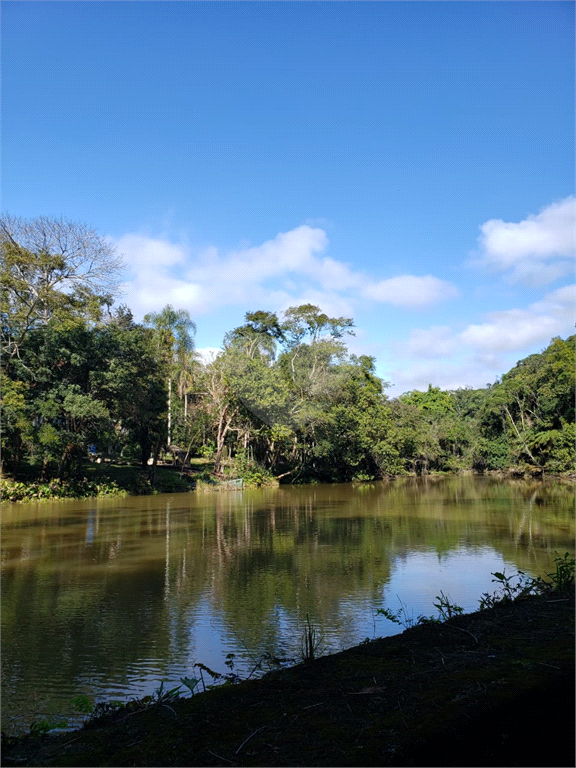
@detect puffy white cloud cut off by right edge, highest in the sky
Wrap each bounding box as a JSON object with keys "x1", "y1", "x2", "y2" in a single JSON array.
[{"x1": 478, "y1": 196, "x2": 576, "y2": 285}]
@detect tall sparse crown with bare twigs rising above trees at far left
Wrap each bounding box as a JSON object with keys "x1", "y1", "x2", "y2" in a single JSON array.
[{"x1": 0, "y1": 215, "x2": 123, "y2": 365}]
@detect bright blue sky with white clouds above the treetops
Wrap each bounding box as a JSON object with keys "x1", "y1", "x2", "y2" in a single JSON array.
[{"x1": 1, "y1": 0, "x2": 575, "y2": 396}]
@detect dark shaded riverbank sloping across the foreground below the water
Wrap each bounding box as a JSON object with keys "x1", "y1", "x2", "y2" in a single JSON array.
[{"x1": 2, "y1": 586, "x2": 574, "y2": 767}]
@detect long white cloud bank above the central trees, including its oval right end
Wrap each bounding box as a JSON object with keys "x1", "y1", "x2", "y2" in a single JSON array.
[{"x1": 116, "y1": 225, "x2": 458, "y2": 316}]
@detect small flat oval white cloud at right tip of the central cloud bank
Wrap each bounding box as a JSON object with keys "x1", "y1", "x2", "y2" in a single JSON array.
[{"x1": 362, "y1": 275, "x2": 460, "y2": 309}]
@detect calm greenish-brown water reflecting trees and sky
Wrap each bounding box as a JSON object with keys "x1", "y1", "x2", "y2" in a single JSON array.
[{"x1": 2, "y1": 477, "x2": 574, "y2": 732}]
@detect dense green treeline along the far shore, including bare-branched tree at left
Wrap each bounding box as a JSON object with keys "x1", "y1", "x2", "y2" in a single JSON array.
[{"x1": 0, "y1": 217, "x2": 575, "y2": 482}]
